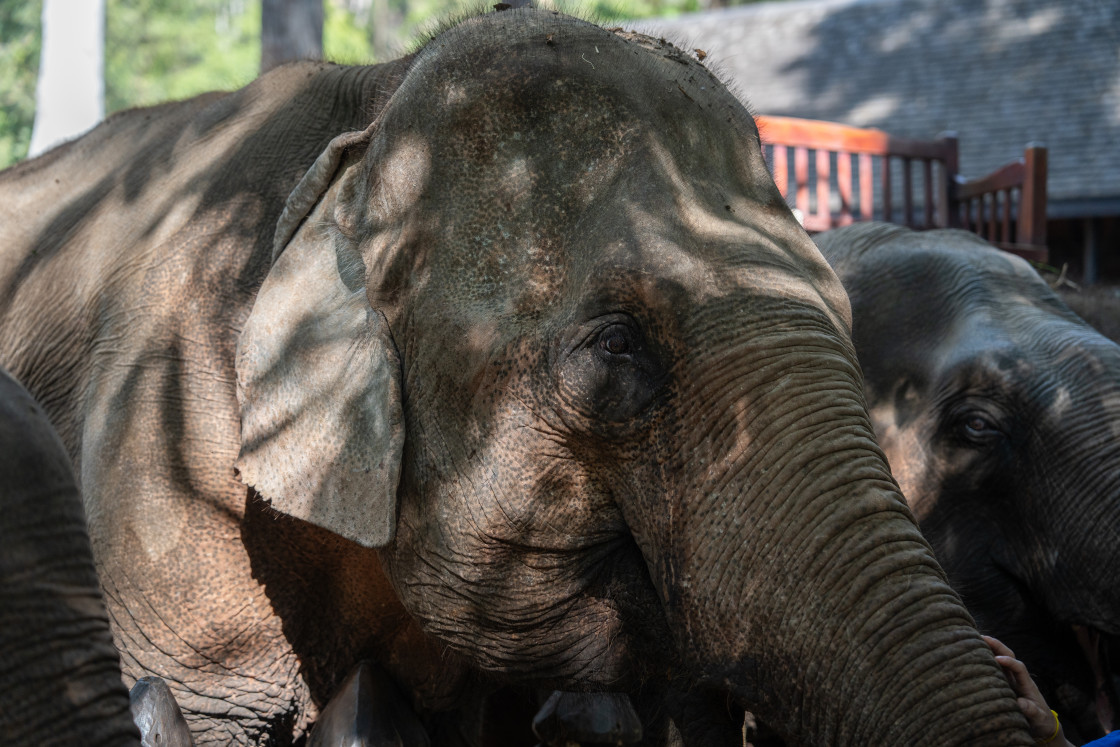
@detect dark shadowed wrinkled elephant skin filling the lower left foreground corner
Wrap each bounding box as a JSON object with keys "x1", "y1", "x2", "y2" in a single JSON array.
[{"x1": 0, "y1": 371, "x2": 140, "y2": 747}]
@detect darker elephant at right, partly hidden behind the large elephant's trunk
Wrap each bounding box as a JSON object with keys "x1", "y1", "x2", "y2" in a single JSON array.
[{"x1": 816, "y1": 224, "x2": 1120, "y2": 740}]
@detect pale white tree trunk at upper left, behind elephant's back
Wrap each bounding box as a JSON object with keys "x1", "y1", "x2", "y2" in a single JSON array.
[{"x1": 28, "y1": 0, "x2": 105, "y2": 156}]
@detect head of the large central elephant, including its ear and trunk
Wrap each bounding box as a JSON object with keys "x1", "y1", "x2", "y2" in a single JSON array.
[{"x1": 237, "y1": 10, "x2": 1029, "y2": 745}]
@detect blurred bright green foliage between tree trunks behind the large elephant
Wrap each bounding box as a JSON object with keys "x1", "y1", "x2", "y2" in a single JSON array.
[{"x1": 0, "y1": 0, "x2": 770, "y2": 168}]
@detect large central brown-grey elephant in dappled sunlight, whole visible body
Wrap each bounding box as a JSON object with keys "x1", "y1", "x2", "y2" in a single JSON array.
[{"x1": 0, "y1": 9, "x2": 1030, "y2": 745}]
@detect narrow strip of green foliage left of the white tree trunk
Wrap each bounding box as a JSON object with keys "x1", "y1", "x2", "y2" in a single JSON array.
[{"x1": 0, "y1": 0, "x2": 43, "y2": 168}]
